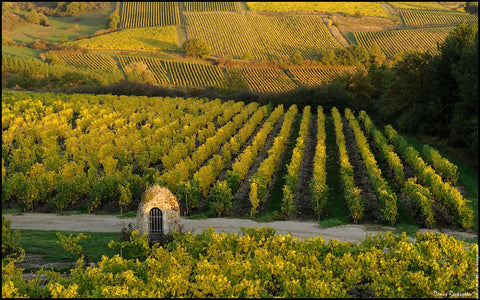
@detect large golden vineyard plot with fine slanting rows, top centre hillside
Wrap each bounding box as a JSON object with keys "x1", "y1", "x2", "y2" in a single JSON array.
[{"x1": 185, "y1": 12, "x2": 340, "y2": 59}]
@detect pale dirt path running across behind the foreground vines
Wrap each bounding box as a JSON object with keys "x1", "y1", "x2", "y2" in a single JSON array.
[{"x1": 2, "y1": 213, "x2": 477, "y2": 242}]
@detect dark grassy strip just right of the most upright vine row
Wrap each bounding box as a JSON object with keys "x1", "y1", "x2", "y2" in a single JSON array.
[{"x1": 320, "y1": 116, "x2": 348, "y2": 227}]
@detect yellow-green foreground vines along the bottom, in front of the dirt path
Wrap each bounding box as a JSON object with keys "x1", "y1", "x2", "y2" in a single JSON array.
[{"x1": 2, "y1": 227, "x2": 478, "y2": 298}]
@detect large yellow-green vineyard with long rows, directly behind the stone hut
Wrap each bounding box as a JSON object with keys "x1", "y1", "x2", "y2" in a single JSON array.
[{"x1": 2, "y1": 92, "x2": 474, "y2": 229}]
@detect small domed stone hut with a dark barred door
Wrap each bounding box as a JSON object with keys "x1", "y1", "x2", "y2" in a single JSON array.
[{"x1": 137, "y1": 185, "x2": 180, "y2": 241}]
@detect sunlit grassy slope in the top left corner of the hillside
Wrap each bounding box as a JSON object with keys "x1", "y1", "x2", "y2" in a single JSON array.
[{"x1": 2, "y1": 2, "x2": 115, "y2": 43}]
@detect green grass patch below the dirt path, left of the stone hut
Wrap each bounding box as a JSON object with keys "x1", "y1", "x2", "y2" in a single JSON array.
[{"x1": 19, "y1": 230, "x2": 120, "y2": 262}]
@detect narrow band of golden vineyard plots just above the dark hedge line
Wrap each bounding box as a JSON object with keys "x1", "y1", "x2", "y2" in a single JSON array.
[{"x1": 54, "y1": 54, "x2": 356, "y2": 93}]
